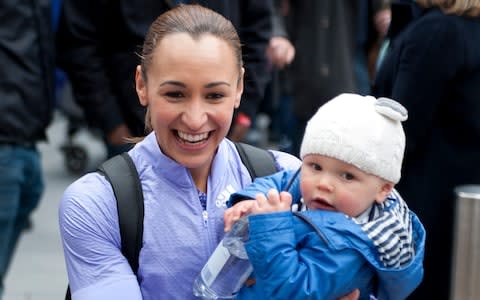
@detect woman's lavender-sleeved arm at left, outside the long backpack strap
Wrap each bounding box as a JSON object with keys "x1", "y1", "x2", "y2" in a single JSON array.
[{"x1": 59, "y1": 174, "x2": 142, "y2": 300}]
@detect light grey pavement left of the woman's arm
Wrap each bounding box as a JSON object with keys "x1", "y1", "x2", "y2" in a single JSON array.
[{"x1": 3, "y1": 115, "x2": 104, "y2": 300}]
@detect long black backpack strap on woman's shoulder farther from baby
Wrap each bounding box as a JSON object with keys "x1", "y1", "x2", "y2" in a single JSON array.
[{"x1": 98, "y1": 153, "x2": 144, "y2": 274}]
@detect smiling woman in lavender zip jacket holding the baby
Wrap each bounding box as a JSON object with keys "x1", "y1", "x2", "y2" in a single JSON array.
[{"x1": 59, "y1": 5, "x2": 300, "y2": 300}]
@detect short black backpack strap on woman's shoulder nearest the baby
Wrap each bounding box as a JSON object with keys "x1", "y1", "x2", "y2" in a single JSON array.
[{"x1": 234, "y1": 142, "x2": 277, "y2": 180}]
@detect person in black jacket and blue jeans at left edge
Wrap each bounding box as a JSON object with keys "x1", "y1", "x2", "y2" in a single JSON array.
[{"x1": 0, "y1": 0, "x2": 54, "y2": 299}]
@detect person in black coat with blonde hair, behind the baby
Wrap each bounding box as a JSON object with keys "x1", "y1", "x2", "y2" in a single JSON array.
[{"x1": 373, "y1": 0, "x2": 480, "y2": 300}]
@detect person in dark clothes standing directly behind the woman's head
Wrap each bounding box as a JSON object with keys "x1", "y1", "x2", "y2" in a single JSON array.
[{"x1": 57, "y1": 0, "x2": 273, "y2": 156}]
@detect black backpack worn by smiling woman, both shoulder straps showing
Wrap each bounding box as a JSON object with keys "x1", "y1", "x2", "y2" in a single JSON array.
[{"x1": 65, "y1": 142, "x2": 277, "y2": 300}]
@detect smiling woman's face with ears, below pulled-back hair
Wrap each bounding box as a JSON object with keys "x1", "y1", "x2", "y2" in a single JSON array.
[{"x1": 136, "y1": 33, "x2": 243, "y2": 173}]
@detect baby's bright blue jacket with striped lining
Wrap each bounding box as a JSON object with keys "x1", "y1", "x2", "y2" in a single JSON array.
[{"x1": 229, "y1": 171, "x2": 425, "y2": 300}]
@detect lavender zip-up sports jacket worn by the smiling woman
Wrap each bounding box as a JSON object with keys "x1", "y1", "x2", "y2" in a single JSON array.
[{"x1": 59, "y1": 133, "x2": 301, "y2": 300}]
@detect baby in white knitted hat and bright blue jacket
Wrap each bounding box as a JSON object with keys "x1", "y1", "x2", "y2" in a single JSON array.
[{"x1": 225, "y1": 94, "x2": 425, "y2": 299}]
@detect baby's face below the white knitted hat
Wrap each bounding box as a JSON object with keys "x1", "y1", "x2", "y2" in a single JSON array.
[{"x1": 300, "y1": 154, "x2": 393, "y2": 217}]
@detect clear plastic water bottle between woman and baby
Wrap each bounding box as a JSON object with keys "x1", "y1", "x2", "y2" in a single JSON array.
[{"x1": 193, "y1": 217, "x2": 253, "y2": 300}]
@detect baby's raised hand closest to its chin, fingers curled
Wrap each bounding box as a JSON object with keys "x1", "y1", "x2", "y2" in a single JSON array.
[{"x1": 251, "y1": 189, "x2": 292, "y2": 214}]
